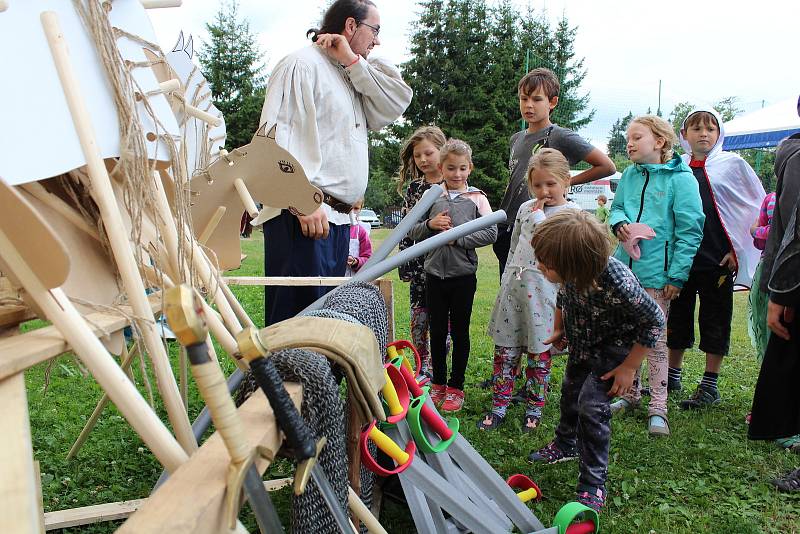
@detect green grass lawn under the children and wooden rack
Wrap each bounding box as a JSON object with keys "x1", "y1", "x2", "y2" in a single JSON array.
[{"x1": 26, "y1": 230, "x2": 800, "y2": 534}]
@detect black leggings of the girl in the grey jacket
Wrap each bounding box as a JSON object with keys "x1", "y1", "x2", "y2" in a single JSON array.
[{"x1": 425, "y1": 273, "x2": 478, "y2": 389}]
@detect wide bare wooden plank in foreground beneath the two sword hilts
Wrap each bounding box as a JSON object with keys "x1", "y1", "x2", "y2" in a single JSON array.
[{"x1": 117, "y1": 382, "x2": 302, "y2": 534}]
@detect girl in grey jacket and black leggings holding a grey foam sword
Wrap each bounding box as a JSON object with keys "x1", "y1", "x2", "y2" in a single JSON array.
[{"x1": 410, "y1": 139, "x2": 497, "y2": 412}]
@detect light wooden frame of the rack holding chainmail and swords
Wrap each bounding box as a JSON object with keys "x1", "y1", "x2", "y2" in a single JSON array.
[{"x1": 0, "y1": 277, "x2": 394, "y2": 533}]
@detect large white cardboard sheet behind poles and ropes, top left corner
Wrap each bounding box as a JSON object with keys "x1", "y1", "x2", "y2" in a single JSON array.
[{"x1": 0, "y1": 0, "x2": 178, "y2": 184}]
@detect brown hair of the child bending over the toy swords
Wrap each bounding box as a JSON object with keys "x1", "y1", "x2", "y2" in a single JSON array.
[{"x1": 531, "y1": 209, "x2": 611, "y2": 291}]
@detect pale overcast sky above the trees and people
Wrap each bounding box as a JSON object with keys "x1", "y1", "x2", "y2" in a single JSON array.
[{"x1": 150, "y1": 0, "x2": 800, "y2": 150}]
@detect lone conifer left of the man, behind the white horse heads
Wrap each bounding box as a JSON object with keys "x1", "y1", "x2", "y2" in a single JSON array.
[{"x1": 199, "y1": 0, "x2": 265, "y2": 149}]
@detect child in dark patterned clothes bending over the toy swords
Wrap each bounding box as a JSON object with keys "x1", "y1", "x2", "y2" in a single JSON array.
[{"x1": 528, "y1": 210, "x2": 665, "y2": 510}]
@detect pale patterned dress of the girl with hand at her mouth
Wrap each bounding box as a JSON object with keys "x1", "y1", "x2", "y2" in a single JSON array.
[{"x1": 489, "y1": 199, "x2": 580, "y2": 354}]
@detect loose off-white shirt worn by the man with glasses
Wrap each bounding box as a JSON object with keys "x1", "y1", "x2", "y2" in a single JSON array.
[{"x1": 257, "y1": 45, "x2": 412, "y2": 224}]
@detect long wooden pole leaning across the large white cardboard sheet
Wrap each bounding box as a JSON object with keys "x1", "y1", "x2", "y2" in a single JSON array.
[{"x1": 41, "y1": 11, "x2": 197, "y2": 453}]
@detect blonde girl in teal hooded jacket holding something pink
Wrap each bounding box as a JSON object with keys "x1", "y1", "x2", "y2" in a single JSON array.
[{"x1": 609, "y1": 115, "x2": 705, "y2": 436}]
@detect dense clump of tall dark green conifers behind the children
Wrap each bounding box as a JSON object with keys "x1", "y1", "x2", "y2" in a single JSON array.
[{"x1": 393, "y1": 0, "x2": 593, "y2": 205}]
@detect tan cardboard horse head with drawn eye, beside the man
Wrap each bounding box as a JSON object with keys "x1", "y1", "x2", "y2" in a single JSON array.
[{"x1": 191, "y1": 124, "x2": 322, "y2": 270}]
